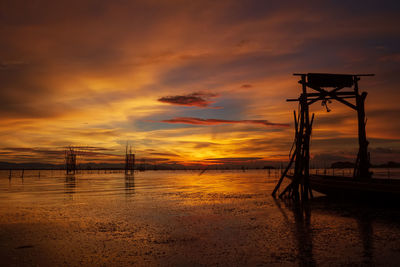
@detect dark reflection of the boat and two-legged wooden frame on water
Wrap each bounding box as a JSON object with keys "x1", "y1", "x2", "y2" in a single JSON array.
[{"x1": 274, "y1": 197, "x2": 386, "y2": 266}]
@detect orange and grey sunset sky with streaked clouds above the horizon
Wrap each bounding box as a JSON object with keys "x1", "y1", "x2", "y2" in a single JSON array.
[{"x1": 0, "y1": 0, "x2": 400, "y2": 168}]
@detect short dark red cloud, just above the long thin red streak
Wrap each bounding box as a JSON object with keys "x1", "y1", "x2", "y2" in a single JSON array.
[{"x1": 158, "y1": 92, "x2": 218, "y2": 107}]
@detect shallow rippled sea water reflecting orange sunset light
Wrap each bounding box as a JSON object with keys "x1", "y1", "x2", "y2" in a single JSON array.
[{"x1": 0, "y1": 170, "x2": 400, "y2": 266}]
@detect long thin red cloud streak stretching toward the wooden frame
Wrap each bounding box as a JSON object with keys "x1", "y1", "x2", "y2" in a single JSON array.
[{"x1": 162, "y1": 117, "x2": 289, "y2": 127}]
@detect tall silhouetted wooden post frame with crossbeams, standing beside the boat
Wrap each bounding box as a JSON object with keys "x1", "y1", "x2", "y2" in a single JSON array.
[{"x1": 272, "y1": 73, "x2": 373, "y2": 199}]
